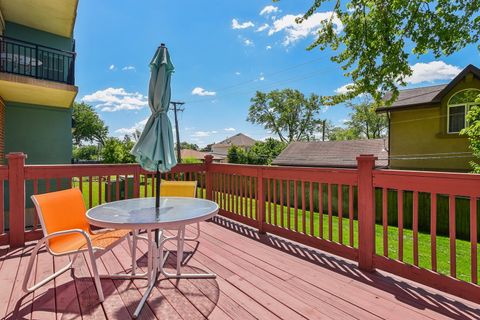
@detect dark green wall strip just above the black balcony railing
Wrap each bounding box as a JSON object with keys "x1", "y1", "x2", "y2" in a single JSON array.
[{"x1": 5, "y1": 21, "x2": 73, "y2": 51}]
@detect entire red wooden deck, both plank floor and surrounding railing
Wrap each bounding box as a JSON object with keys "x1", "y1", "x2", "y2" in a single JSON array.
[{"x1": 0, "y1": 154, "x2": 480, "y2": 319}]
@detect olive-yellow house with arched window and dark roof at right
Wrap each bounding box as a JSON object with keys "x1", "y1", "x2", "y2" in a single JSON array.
[{"x1": 377, "y1": 65, "x2": 480, "y2": 171}]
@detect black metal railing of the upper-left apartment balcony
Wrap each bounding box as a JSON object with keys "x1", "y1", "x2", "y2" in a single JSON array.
[{"x1": 0, "y1": 36, "x2": 75, "y2": 85}]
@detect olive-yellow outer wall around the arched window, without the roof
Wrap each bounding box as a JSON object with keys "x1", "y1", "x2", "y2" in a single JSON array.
[{"x1": 390, "y1": 75, "x2": 480, "y2": 171}]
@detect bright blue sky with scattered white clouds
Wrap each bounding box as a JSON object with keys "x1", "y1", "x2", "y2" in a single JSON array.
[{"x1": 75, "y1": 0, "x2": 480, "y2": 146}]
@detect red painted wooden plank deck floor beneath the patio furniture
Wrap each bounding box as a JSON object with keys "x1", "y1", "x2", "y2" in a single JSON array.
[{"x1": 0, "y1": 218, "x2": 480, "y2": 320}]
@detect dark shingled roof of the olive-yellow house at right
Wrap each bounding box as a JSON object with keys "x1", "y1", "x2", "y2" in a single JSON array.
[{"x1": 377, "y1": 64, "x2": 480, "y2": 112}]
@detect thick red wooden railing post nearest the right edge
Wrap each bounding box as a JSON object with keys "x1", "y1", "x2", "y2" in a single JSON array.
[{"x1": 357, "y1": 154, "x2": 377, "y2": 271}]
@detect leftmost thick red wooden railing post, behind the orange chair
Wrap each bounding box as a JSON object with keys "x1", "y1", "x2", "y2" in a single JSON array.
[{"x1": 7, "y1": 152, "x2": 27, "y2": 248}]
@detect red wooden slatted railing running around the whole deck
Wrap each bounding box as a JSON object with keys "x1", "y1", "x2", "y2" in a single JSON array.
[{"x1": 0, "y1": 154, "x2": 480, "y2": 303}]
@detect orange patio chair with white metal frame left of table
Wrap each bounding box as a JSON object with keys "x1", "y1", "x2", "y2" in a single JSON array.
[{"x1": 22, "y1": 189, "x2": 134, "y2": 302}]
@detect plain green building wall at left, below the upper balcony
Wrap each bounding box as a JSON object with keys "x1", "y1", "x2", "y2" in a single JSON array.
[{"x1": 5, "y1": 101, "x2": 72, "y2": 164}]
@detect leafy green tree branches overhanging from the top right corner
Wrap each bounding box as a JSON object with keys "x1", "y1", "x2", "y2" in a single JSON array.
[{"x1": 297, "y1": 0, "x2": 480, "y2": 104}]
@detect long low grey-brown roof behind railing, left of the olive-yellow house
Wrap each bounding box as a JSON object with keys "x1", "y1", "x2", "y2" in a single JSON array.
[{"x1": 272, "y1": 139, "x2": 388, "y2": 168}]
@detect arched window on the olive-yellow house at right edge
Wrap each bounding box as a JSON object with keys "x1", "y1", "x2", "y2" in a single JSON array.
[{"x1": 447, "y1": 89, "x2": 480, "y2": 133}]
